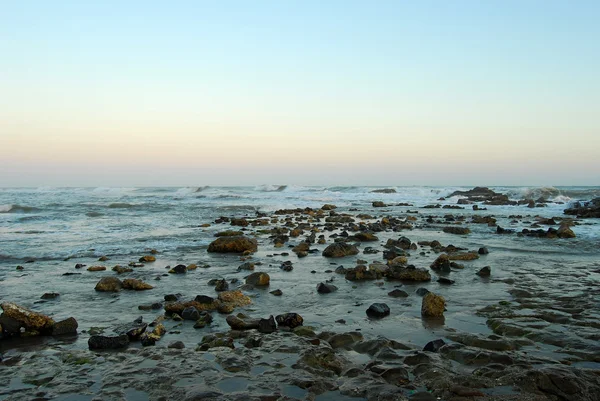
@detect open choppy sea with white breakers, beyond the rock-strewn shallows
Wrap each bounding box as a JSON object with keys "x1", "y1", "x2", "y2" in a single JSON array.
[{"x1": 0, "y1": 185, "x2": 600, "y2": 265}]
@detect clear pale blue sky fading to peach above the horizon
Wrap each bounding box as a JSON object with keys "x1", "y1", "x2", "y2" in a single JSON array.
[{"x1": 0, "y1": 0, "x2": 600, "y2": 187}]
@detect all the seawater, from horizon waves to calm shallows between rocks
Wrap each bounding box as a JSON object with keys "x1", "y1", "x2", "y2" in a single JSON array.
[{"x1": 0, "y1": 185, "x2": 600, "y2": 363}]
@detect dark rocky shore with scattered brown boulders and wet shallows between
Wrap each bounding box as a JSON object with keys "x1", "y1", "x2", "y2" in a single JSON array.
[{"x1": 0, "y1": 187, "x2": 600, "y2": 401}]
